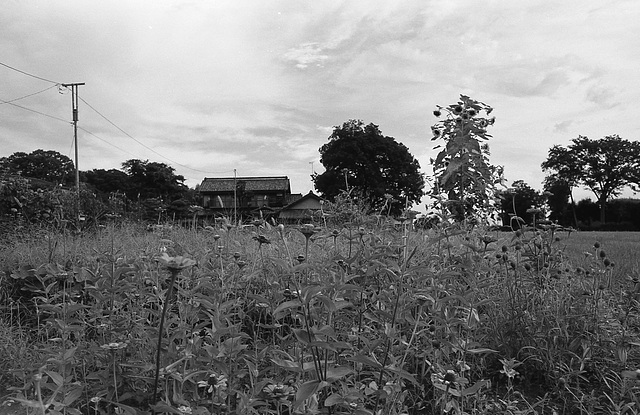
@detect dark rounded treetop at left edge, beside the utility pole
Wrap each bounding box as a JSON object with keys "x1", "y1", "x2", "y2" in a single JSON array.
[{"x1": 0, "y1": 149, "x2": 75, "y2": 184}]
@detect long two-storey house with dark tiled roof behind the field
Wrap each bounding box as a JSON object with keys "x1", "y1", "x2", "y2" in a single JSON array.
[{"x1": 198, "y1": 176, "x2": 291, "y2": 217}]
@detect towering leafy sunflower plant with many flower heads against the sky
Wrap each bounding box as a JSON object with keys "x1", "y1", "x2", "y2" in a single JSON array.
[{"x1": 431, "y1": 95, "x2": 502, "y2": 220}]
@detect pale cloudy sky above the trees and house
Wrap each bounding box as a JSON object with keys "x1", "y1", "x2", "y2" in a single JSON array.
[{"x1": 0, "y1": 0, "x2": 640, "y2": 213}]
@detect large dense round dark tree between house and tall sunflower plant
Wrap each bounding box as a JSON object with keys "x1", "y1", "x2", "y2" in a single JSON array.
[{"x1": 313, "y1": 120, "x2": 424, "y2": 214}]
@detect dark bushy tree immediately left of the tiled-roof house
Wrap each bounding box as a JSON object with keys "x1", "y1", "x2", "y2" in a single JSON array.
[{"x1": 122, "y1": 159, "x2": 188, "y2": 200}]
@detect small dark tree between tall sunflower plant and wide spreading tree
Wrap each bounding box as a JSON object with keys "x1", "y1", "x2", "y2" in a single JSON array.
[{"x1": 498, "y1": 180, "x2": 544, "y2": 229}]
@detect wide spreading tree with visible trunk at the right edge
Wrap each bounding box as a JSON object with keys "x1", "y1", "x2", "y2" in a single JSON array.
[{"x1": 542, "y1": 135, "x2": 640, "y2": 223}]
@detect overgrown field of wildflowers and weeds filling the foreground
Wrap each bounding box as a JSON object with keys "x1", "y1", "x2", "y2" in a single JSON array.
[{"x1": 0, "y1": 218, "x2": 640, "y2": 415}]
